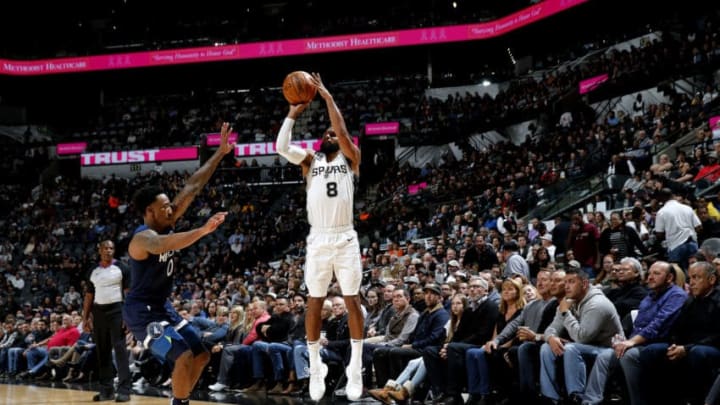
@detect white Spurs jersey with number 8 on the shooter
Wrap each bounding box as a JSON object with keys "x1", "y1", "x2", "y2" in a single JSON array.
[{"x1": 307, "y1": 152, "x2": 355, "y2": 229}]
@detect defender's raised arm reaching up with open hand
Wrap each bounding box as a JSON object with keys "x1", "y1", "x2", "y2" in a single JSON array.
[{"x1": 173, "y1": 122, "x2": 235, "y2": 221}]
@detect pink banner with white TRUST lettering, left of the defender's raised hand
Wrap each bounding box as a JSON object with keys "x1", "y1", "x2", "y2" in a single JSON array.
[{"x1": 80, "y1": 146, "x2": 198, "y2": 166}]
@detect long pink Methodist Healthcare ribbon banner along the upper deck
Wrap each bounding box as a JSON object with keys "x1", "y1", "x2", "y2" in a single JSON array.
[{"x1": 0, "y1": 0, "x2": 588, "y2": 76}]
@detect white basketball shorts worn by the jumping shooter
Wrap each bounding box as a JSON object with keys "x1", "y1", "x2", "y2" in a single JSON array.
[{"x1": 305, "y1": 227, "x2": 362, "y2": 298}]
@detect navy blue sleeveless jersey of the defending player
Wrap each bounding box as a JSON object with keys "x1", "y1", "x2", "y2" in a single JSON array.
[{"x1": 125, "y1": 225, "x2": 175, "y2": 304}]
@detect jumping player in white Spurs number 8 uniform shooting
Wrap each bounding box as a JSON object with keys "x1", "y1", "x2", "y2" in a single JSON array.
[{"x1": 276, "y1": 73, "x2": 363, "y2": 401}]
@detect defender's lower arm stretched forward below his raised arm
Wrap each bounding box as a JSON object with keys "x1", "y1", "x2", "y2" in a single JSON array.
[{"x1": 128, "y1": 212, "x2": 227, "y2": 260}]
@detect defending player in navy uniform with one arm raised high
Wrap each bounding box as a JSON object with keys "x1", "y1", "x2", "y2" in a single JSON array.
[{"x1": 123, "y1": 123, "x2": 234, "y2": 405}]
